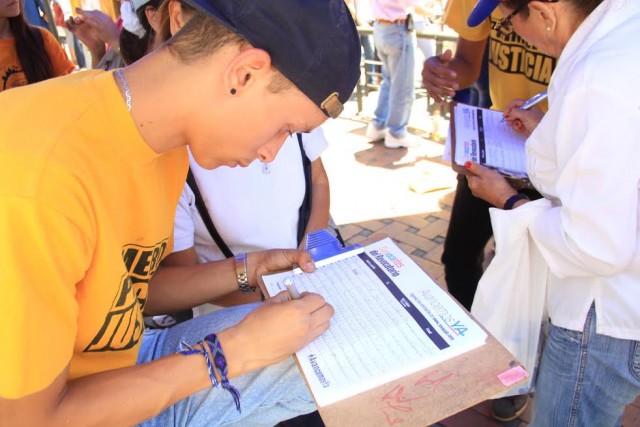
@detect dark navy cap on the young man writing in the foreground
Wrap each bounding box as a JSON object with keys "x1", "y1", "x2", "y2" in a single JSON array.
[{"x1": 183, "y1": 0, "x2": 361, "y2": 118}]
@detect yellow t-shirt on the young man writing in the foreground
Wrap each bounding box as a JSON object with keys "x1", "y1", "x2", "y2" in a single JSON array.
[{"x1": 0, "y1": 71, "x2": 188, "y2": 398}]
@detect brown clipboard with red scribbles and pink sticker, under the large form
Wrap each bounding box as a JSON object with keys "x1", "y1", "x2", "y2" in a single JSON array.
[{"x1": 262, "y1": 230, "x2": 528, "y2": 427}]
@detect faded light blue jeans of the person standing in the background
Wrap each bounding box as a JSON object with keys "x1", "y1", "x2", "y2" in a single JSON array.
[{"x1": 373, "y1": 22, "x2": 416, "y2": 138}]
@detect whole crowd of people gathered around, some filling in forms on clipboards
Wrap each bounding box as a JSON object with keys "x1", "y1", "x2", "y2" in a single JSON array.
[{"x1": 0, "y1": 0, "x2": 640, "y2": 427}]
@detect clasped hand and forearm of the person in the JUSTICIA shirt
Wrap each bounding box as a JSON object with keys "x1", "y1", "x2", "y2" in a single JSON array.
[{"x1": 422, "y1": 38, "x2": 487, "y2": 102}]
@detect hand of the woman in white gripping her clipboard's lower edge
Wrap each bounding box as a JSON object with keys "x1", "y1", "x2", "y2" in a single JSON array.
[{"x1": 464, "y1": 162, "x2": 518, "y2": 209}]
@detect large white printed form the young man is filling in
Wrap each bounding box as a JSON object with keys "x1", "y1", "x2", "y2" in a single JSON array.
[{"x1": 263, "y1": 238, "x2": 487, "y2": 406}]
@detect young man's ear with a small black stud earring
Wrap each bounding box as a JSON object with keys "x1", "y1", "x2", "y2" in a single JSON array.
[{"x1": 225, "y1": 46, "x2": 273, "y2": 92}]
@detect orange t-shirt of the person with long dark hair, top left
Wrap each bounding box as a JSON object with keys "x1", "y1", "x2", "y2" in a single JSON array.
[{"x1": 0, "y1": 27, "x2": 75, "y2": 92}]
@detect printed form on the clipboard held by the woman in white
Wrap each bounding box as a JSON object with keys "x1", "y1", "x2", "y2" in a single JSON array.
[{"x1": 453, "y1": 104, "x2": 527, "y2": 178}]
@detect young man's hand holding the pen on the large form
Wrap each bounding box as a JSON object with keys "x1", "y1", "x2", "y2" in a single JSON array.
[{"x1": 218, "y1": 291, "x2": 334, "y2": 376}]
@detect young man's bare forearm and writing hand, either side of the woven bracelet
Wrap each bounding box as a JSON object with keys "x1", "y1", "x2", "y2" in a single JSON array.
[{"x1": 0, "y1": 292, "x2": 333, "y2": 427}]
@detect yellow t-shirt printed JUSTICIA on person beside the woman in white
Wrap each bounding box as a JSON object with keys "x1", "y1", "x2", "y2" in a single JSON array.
[{"x1": 444, "y1": 0, "x2": 555, "y2": 110}]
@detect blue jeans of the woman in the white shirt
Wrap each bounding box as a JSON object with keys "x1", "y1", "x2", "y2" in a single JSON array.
[{"x1": 530, "y1": 305, "x2": 640, "y2": 427}]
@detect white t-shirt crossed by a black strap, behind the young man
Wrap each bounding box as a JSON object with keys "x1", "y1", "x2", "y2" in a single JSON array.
[{"x1": 173, "y1": 128, "x2": 328, "y2": 263}]
